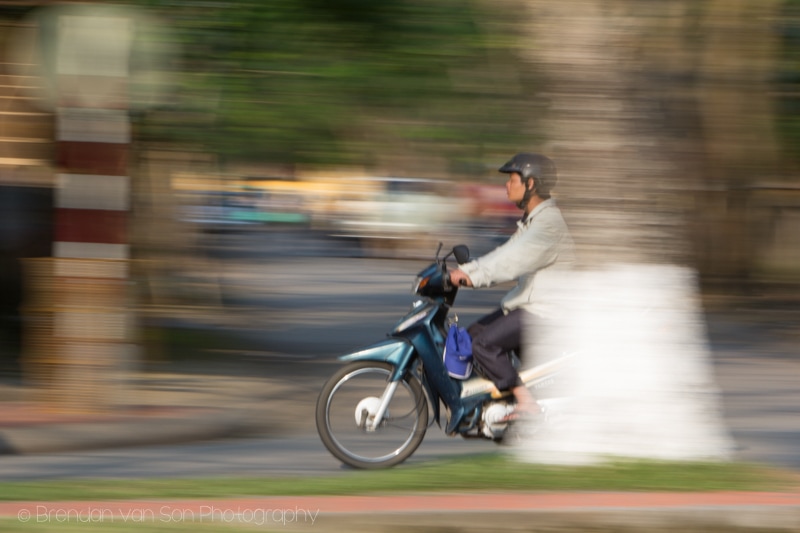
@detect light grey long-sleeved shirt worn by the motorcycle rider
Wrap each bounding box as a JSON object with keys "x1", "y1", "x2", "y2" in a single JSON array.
[{"x1": 460, "y1": 198, "x2": 575, "y2": 317}]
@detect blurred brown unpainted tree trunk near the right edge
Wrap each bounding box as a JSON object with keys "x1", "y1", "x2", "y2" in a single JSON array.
[{"x1": 692, "y1": 0, "x2": 782, "y2": 288}]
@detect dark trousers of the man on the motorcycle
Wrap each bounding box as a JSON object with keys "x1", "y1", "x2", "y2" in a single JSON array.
[{"x1": 467, "y1": 309, "x2": 527, "y2": 390}]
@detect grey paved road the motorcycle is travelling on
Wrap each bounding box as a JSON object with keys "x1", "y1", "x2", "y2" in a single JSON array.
[{"x1": 0, "y1": 231, "x2": 800, "y2": 479}]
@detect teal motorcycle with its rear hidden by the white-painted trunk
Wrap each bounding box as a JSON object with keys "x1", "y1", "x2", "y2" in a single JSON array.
[{"x1": 316, "y1": 245, "x2": 570, "y2": 469}]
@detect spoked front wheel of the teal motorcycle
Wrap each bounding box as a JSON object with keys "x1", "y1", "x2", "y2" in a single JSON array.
[{"x1": 316, "y1": 361, "x2": 428, "y2": 469}]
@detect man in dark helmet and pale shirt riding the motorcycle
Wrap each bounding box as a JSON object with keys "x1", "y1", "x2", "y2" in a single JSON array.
[{"x1": 450, "y1": 153, "x2": 575, "y2": 419}]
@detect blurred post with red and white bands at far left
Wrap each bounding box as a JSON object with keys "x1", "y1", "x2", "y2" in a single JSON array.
[{"x1": 29, "y1": 13, "x2": 134, "y2": 411}]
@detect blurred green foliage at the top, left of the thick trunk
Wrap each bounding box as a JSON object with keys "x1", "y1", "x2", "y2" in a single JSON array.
[{"x1": 125, "y1": 0, "x2": 533, "y2": 170}]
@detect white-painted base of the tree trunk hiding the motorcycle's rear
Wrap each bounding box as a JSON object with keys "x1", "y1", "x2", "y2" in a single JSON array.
[{"x1": 516, "y1": 264, "x2": 732, "y2": 464}]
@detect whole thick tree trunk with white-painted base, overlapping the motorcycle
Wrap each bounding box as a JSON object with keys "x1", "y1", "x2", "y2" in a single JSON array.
[{"x1": 515, "y1": 0, "x2": 732, "y2": 464}]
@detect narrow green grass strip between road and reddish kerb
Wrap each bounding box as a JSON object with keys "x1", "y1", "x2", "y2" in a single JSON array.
[{"x1": 0, "y1": 454, "x2": 797, "y2": 501}]
